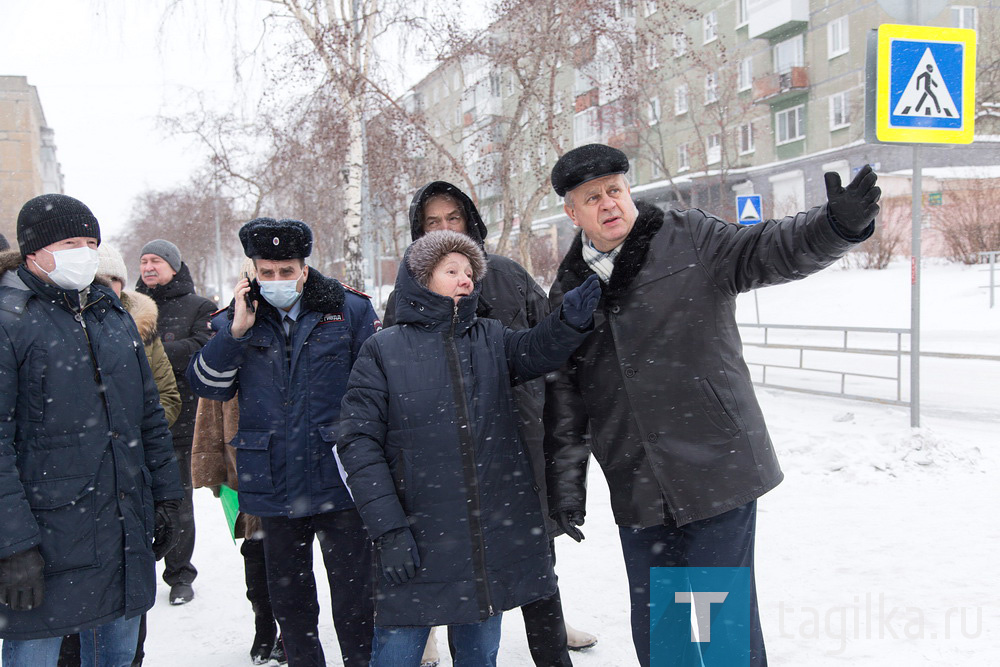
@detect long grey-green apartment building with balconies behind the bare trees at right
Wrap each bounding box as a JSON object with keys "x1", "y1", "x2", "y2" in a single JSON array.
[{"x1": 386, "y1": 0, "x2": 1000, "y2": 264}]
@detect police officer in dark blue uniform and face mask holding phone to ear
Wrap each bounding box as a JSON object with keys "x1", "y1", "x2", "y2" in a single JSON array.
[{"x1": 187, "y1": 218, "x2": 382, "y2": 667}]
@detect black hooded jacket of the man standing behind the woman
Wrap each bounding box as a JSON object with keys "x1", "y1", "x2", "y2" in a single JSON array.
[{"x1": 382, "y1": 181, "x2": 559, "y2": 535}]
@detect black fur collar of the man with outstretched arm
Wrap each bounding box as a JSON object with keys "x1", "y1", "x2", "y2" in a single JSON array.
[{"x1": 556, "y1": 201, "x2": 664, "y2": 298}]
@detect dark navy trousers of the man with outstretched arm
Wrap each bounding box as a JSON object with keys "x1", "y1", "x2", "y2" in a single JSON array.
[{"x1": 618, "y1": 501, "x2": 767, "y2": 667}]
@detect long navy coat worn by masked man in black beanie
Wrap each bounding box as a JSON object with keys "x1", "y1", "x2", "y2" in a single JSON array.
[{"x1": 0, "y1": 253, "x2": 182, "y2": 639}]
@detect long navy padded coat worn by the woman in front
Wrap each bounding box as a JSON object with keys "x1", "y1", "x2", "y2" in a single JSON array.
[{"x1": 337, "y1": 251, "x2": 587, "y2": 626}]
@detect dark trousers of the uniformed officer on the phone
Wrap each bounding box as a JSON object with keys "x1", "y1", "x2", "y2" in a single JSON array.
[{"x1": 261, "y1": 508, "x2": 375, "y2": 667}]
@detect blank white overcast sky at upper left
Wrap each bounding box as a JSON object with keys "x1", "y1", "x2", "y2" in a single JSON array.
[{"x1": 0, "y1": 0, "x2": 470, "y2": 236}]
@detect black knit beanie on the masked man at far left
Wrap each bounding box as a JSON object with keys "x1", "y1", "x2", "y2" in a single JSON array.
[{"x1": 17, "y1": 194, "x2": 101, "y2": 257}]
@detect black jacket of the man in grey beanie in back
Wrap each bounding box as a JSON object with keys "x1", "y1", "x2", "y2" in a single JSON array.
[{"x1": 135, "y1": 262, "x2": 217, "y2": 449}]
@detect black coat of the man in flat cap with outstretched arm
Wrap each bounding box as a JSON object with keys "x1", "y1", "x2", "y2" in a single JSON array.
[{"x1": 545, "y1": 202, "x2": 871, "y2": 528}]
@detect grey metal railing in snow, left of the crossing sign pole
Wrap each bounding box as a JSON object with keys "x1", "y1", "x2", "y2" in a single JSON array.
[{"x1": 739, "y1": 324, "x2": 910, "y2": 406}]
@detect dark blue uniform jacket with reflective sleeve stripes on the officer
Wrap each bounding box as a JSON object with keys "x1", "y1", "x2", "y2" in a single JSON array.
[{"x1": 187, "y1": 267, "x2": 382, "y2": 518}]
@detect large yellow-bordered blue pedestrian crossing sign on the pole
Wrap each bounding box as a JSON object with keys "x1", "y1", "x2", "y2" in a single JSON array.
[{"x1": 875, "y1": 24, "x2": 976, "y2": 144}]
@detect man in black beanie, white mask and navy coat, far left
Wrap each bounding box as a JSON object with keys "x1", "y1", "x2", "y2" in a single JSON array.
[{"x1": 0, "y1": 194, "x2": 182, "y2": 667}]
